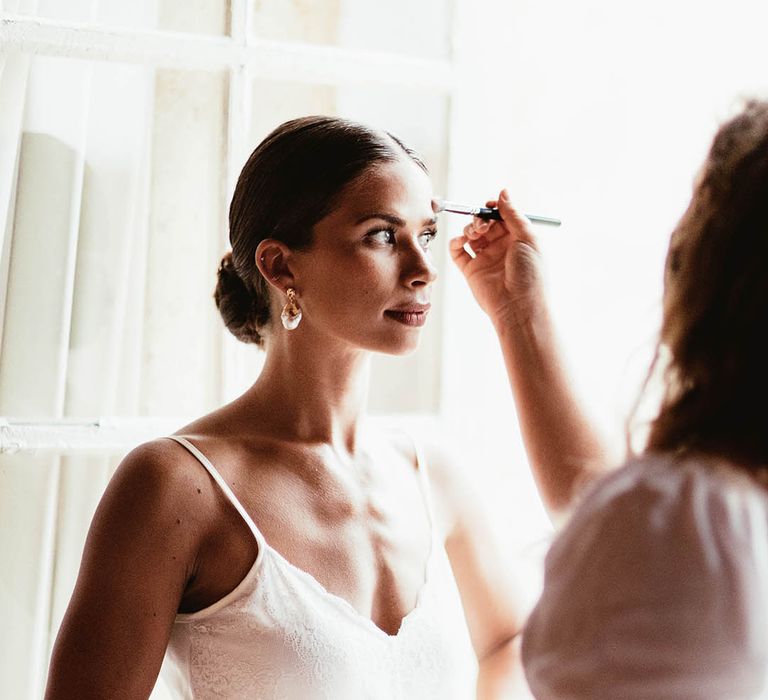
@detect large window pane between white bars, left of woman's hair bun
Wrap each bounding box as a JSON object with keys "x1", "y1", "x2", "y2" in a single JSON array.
[{"x1": 0, "y1": 57, "x2": 227, "y2": 418}]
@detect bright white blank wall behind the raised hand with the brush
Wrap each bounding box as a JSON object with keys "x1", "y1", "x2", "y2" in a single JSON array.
[{"x1": 443, "y1": 0, "x2": 768, "y2": 539}]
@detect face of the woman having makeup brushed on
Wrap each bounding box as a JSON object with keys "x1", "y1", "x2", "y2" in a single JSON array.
[{"x1": 295, "y1": 157, "x2": 437, "y2": 354}]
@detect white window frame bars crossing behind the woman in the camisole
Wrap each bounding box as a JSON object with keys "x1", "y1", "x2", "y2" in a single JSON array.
[{"x1": 0, "y1": 0, "x2": 456, "y2": 454}]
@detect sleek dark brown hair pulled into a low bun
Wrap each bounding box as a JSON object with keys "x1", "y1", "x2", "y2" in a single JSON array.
[{"x1": 214, "y1": 116, "x2": 427, "y2": 345}]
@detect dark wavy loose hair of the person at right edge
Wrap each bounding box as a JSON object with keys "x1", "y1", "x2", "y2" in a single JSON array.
[{"x1": 647, "y1": 101, "x2": 768, "y2": 473}]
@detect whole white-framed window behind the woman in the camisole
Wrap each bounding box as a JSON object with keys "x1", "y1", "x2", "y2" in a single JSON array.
[{"x1": 0, "y1": 0, "x2": 452, "y2": 698}]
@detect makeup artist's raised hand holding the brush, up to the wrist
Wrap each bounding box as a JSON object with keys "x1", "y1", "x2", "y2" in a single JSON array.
[{"x1": 450, "y1": 190, "x2": 544, "y2": 326}]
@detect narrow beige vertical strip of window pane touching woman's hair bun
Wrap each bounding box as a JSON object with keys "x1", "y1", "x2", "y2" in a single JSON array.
[{"x1": 139, "y1": 65, "x2": 227, "y2": 415}]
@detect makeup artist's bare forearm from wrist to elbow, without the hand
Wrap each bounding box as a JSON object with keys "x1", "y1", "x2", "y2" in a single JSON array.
[{"x1": 494, "y1": 310, "x2": 608, "y2": 515}]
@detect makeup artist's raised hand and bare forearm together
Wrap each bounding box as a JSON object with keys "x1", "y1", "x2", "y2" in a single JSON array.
[{"x1": 450, "y1": 190, "x2": 614, "y2": 522}]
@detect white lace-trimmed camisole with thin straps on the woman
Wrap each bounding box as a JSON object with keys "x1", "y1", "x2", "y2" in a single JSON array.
[{"x1": 163, "y1": 436, "x2": 477, "y2": 700}]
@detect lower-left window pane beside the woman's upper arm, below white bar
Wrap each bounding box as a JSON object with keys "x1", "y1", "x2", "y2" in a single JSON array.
[{"x1": 0, "y1": 453, "x2": 136, "y2": 698}]
